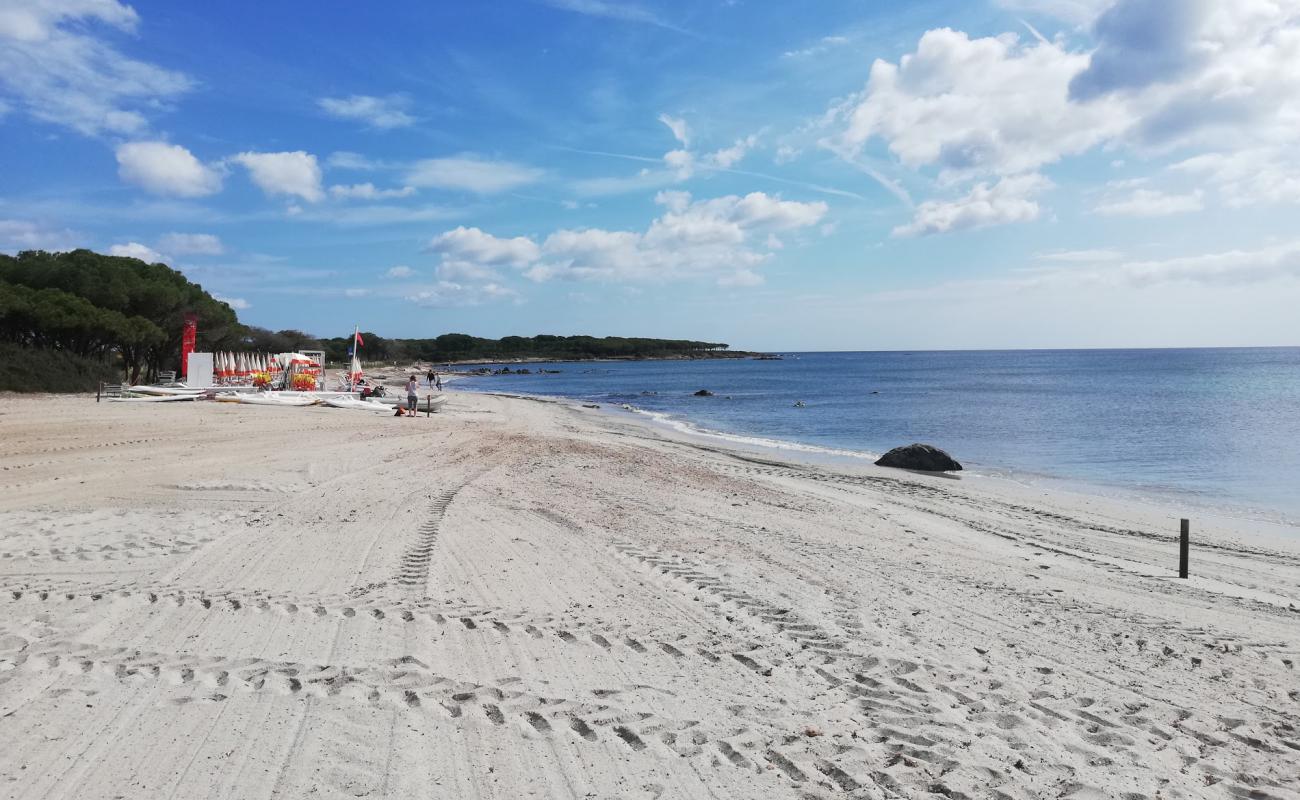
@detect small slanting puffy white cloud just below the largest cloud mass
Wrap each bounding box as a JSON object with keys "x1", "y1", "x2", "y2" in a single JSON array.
[{"x1": 893, "y1": 173, "x2": 1052, "y2": 237}]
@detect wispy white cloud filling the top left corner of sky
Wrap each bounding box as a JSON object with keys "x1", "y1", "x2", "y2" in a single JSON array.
[{"x1": 0, "y1": 0, "x2": 191, "y2": 135}]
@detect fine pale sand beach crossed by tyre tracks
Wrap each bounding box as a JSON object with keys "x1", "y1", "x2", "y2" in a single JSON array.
[{"x1": 0, "y1": 394, "x2": 1300, "y2": 800}]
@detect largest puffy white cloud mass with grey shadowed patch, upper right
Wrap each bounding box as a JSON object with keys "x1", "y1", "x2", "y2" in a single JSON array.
[{"x1": 820, "y1": 0, "x2": 1300, "y2": 230}]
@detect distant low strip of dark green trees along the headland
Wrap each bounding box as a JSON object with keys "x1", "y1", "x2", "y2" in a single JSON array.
[{"x1": 320, "y1": 332, "x2": 749, "y2": 363}]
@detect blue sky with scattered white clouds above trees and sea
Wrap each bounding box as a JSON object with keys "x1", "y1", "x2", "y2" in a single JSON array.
[{"x1": 0, "y1": 0, "x2": 1300, "y2": 350}]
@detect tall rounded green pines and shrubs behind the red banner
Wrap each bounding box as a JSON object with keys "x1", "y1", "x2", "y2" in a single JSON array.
[{"x1": 0, "y1": 250, "x2": 244, "y2": 392}]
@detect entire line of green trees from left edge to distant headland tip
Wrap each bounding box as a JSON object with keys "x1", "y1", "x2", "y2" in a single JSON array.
[{"x1": 0, "y1": 250, "x2": 749, "y2": 392}]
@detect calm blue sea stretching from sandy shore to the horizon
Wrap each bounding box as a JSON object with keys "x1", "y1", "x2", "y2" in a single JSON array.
[{"x1": 456, "y1": 347, "x2": 1300, "y2": 526}]
